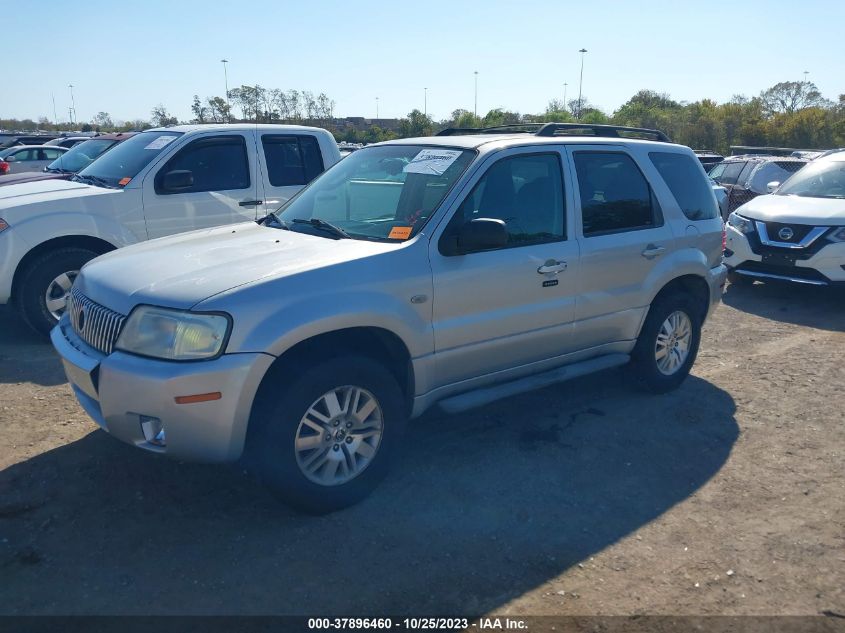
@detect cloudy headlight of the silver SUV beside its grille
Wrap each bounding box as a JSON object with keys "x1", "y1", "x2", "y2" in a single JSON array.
[{"x1": 115, "y1": 306, "x2": 231, "y2": 360}]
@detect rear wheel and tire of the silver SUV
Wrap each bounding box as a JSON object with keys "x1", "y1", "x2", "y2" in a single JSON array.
[{"x1": 631, "y1": 293, "x2": 701, "y2": 393}]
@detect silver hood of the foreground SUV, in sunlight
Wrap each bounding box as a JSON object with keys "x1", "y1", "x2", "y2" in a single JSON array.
[{"x1": 76, "y1": 222, "x2": 400, "y2": 314}]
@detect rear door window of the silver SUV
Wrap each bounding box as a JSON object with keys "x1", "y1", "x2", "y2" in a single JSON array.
[{"x1": 574, "y1": 152, "x2": 663, "y2": 237}]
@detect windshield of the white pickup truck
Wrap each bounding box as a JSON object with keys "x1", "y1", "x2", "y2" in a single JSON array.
[{"x1": 79, "y1": 131, "x2": 182, "y2": 187}]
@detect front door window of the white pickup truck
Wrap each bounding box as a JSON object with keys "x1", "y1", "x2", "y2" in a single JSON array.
[{"x1": 156, "y1": 134, "x2": 250, "y2": 194}]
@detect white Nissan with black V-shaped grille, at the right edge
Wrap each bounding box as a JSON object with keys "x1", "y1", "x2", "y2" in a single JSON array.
[{"x1": 725, "y1": 151, "x2": 845, "y2": 286}]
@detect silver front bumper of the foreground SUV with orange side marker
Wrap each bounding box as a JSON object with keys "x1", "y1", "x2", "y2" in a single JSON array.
[{"x1": 50, "y1": 317, "x2": 274, "y2": 462}]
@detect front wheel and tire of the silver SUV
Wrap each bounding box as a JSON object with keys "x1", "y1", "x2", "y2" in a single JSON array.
[{"x1": 246, "y1": 356, "x2": 405, "y2": 514}]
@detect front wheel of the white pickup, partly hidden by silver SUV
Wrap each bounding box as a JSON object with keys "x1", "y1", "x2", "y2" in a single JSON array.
[{"x1": 16, "y1": 247, "x2": 99, "y2": 336}]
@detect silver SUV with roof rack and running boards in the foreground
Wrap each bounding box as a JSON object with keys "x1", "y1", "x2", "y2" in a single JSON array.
[{"x1": 52, "y1": 124, "x2": 726, "y2": 512}]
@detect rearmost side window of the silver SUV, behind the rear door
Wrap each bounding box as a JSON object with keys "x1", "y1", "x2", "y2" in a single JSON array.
[{"x1": 648, "y1": 152, "x2": 719, "y2": 220}]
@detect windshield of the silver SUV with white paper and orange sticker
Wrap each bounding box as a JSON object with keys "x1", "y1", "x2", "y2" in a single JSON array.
[{"x1": 275, "y1": 145, "x2": 475, "y2": 240}]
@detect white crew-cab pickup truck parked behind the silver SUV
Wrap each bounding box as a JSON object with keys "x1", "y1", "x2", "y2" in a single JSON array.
[{"x1": 0, "y1": 124, "x2": 340, "y2": 334}]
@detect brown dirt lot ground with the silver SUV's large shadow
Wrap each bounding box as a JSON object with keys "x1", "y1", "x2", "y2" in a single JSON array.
[{"x1": 0, "y1": 284, "x2": 845, "y2": 615}]
